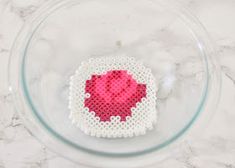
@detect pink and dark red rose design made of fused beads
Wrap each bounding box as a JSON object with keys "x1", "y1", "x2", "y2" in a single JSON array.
[{"x1": 84, "y1": 70, "x2": 146, "y2": 121}]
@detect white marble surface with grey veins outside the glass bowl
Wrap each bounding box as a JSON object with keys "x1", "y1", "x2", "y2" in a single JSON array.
[{"x1": 0, "y1": 0, "x2": 235, "y2": 168}]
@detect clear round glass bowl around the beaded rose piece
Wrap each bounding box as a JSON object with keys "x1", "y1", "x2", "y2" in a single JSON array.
[{"x1": 9, "y1": 0, "x2": 220, "y2": 167}]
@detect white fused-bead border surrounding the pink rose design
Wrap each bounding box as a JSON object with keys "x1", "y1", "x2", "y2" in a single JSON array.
[{"x1": 69, "y1": 56, "x2": 157, "y2": 138}]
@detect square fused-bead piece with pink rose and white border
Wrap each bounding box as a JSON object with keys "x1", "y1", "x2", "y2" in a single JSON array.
[{"x1": 69, "y1": 57, "x2": 157, "y2": 138}]
